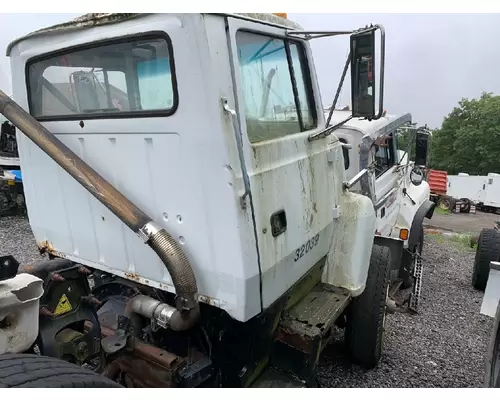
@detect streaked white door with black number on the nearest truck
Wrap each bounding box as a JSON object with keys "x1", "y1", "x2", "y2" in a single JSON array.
[{"x1": 227, "y1": 17, "x2": 344, "y2": 307}]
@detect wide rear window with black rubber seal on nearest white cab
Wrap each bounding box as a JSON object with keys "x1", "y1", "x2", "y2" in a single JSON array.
[{"x1": 28, "y1": 36, "x2": 177, "y2": 119}]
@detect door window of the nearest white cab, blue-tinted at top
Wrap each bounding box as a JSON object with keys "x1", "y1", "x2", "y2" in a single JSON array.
[{"x1": 236, "y1": 32, "x2": 316, "y2": 143}]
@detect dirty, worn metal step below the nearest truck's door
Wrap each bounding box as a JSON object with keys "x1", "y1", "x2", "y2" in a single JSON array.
[{"x1": 272, "y1": 283, "x2": 351, "y2": 382}]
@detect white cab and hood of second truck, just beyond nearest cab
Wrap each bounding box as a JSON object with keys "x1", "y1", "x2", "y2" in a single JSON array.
[{"x1": 332, "y1": 111, "x2": 430, "y2": 245}]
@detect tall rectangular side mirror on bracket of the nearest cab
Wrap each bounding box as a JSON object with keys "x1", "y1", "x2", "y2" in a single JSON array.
[{"x1": 350, "y1": 25, "x2": 385, "y2": 119}]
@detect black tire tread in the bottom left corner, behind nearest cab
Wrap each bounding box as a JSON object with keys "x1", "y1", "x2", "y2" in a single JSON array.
[{"x1": 0, "y1": 354, "x2": 122, "y2": 388}]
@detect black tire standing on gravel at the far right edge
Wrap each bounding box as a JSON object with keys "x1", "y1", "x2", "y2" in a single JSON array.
[{"x1": 472, "y1": 229, "x2": 500, "y2": 291}]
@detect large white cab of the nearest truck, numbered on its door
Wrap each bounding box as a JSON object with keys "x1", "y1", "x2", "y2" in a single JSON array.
[{"x1": 9, "y1": 14, "x2": 373, "y2": 321}]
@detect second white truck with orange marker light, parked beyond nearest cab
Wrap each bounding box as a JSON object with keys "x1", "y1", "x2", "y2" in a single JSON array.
[{"x1": 324, "y1": 110, "x2": 434, "y2": 304}]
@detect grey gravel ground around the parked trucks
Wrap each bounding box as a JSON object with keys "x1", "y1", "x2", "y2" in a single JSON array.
[{"x1": 0, "y1": 217, "x2": 492, "y2": 387}]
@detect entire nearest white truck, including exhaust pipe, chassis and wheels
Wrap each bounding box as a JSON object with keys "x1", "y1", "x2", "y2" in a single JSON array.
[{"x1": 0, "y1": 14, "x2": 433, "y2": 387}]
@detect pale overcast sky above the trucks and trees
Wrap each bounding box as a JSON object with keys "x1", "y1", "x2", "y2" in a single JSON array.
[{"x1": 0, "y1": 13, "x2": 500, "y2": 128}]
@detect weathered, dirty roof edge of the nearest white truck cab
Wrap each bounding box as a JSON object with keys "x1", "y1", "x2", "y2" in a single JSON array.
[{"x1": 6, "y1": 13, "x2": 303, "y2": 57}]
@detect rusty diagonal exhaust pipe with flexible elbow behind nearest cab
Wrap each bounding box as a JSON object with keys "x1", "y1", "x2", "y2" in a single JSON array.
[{"x1": 0, "y1": 90, "x2": 199, "y2": 330}]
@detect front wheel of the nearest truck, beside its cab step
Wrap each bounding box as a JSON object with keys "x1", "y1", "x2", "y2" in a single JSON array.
[{"x1": 345, "y1": 245, "x2": 391, "y2": 368}]
